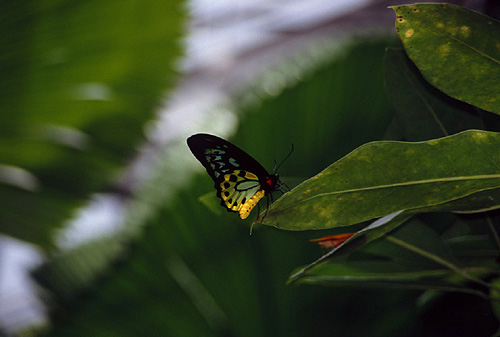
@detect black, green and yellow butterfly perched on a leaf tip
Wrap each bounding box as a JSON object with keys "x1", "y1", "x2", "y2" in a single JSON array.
[{"x1": 187, "y1": 133, "x2": 282, "y2": 219}]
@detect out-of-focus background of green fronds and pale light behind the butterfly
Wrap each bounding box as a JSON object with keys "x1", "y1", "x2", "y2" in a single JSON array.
[{"x1": 0, "y1": 0, "x2": 499, "y2": 336}]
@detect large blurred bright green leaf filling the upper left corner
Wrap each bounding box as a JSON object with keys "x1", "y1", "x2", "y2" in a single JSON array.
[{"x1": 0, "y1": 0, "x2": 184, "y2": 247}]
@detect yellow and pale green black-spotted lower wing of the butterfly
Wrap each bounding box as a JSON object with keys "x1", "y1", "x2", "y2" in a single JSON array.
[{"x1": 219, "y1": 170, "x2": 265, "y2": 219}]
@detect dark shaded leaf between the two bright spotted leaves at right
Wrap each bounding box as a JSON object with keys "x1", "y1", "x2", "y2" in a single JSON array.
[{"x1": 384, "y1": 48, "x2": 484, "y2": 141}]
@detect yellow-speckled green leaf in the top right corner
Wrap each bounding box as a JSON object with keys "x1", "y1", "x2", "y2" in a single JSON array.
[{"x1": 391, "y1": 4, "x2": 500, "y2": 114}]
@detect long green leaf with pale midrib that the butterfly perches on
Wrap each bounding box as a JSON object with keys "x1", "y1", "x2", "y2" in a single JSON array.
[{"x1": 264, "y1": 130, "x2": 500, "y2": 230}]
